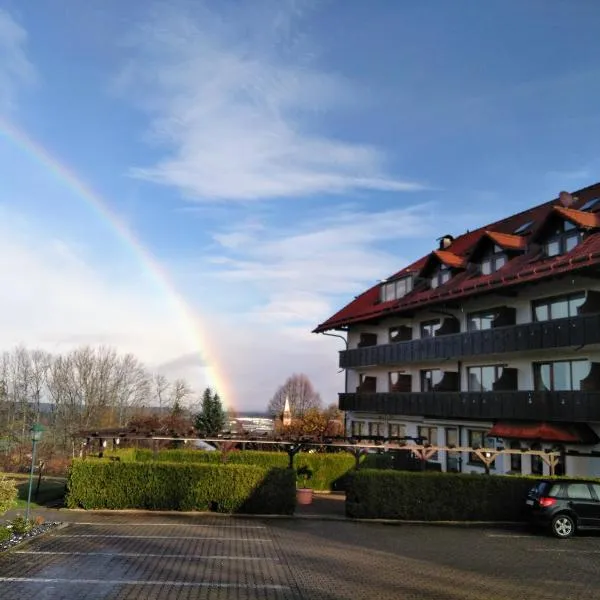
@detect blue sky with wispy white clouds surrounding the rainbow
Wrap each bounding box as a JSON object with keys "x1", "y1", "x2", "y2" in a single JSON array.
[{"x1": 0, "y1": 0, "x2": 600, "y2": 408}]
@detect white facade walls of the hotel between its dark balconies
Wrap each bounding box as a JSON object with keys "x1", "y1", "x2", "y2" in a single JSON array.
[{"x1": 346, "y1": 276, "x2": 600, "y2": 476}]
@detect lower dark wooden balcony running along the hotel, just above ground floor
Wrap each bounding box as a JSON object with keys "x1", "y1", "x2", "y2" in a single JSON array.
[{"x1": 339, "y1": 391, "x2": 600, "y2": 423}]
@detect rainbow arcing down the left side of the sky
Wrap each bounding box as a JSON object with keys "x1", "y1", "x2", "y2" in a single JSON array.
[{"x1": 0, "y1": 117, "x2": 233, "y2": 408}]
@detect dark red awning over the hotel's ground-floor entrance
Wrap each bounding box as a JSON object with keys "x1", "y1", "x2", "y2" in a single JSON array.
[{"x1": 488, "y1": 422, "x2": 598, "y2": 444}]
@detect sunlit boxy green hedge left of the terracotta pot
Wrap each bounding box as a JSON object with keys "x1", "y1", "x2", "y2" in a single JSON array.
[{"x1": 66, "y1": 459, "x2": 296, "y2": 514}]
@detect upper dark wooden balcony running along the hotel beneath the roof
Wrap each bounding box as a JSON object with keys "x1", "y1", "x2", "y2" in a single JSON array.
[{"x1": 340, "y1": 314, "x2": 600, "y2": 369}]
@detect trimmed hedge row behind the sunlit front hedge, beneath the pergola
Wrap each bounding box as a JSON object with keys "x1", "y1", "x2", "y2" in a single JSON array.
[{"x1": 110, "y1": 448, "x2": 354, "y2": 491}]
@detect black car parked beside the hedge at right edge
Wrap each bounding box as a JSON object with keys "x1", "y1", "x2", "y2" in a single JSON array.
[{"x1": 525, "y1": 479, "x2": 600, "y2": 538}]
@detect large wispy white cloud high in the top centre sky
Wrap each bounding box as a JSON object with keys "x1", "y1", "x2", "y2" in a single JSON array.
[{"x1": 117, "y1": 0, "x2": 422, "y2": 200}]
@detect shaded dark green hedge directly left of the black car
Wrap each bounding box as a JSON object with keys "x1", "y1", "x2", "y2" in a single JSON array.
[{"x1": 346, "y1": 469, "x2": 536, "y2": 521}]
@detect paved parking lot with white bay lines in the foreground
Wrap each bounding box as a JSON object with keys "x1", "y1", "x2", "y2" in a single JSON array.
[{"x1": 0, "y1": 513, "x2": 600, "y2": 600}]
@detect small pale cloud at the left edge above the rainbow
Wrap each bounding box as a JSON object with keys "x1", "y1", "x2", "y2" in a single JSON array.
[{"x1": 0, "y1": 8, "x2": 35, "y2": 113}]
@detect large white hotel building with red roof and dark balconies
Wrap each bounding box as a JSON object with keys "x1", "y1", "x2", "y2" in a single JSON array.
[{"x1": 315, "y1": 183, "x2": 600, "y2": 476}]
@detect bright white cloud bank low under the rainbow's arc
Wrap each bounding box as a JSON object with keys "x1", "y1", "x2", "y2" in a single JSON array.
[{"x1": 0, "y1": 210, "x2": 203, "y2": 386}]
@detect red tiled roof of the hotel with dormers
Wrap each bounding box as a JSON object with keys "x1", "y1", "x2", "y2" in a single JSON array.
[{"x1": 314, "y1": 183, "x2": 600, "y2": 333}]
